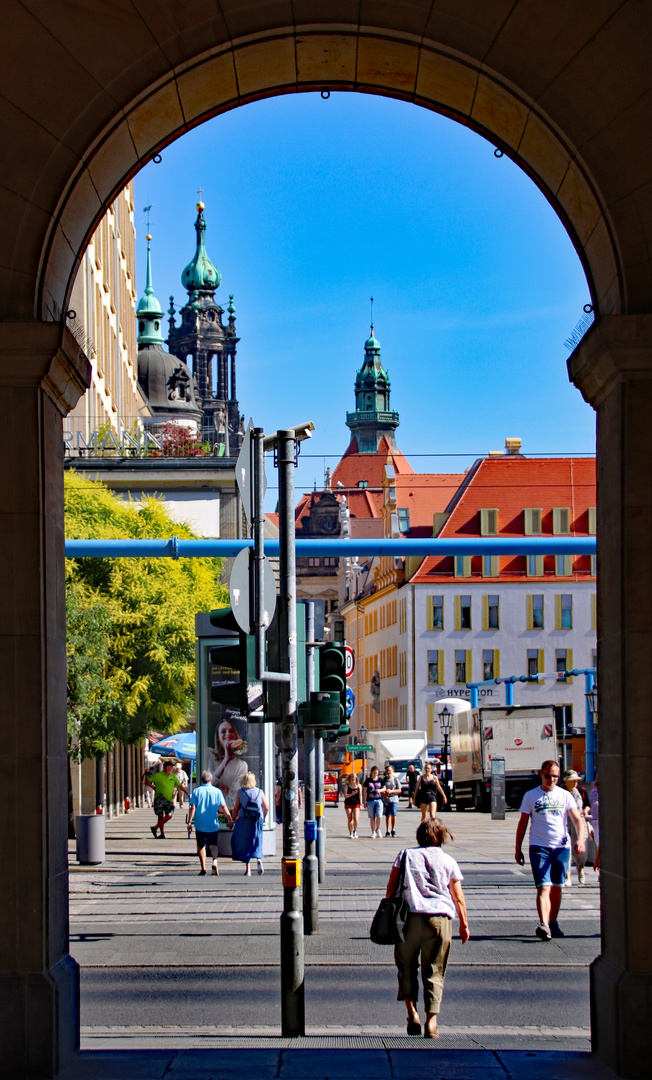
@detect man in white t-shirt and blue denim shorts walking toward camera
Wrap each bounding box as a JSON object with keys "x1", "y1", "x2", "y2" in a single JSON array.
[{"x1": 514, "y1": 761, "x2": 584, "y2": 942}]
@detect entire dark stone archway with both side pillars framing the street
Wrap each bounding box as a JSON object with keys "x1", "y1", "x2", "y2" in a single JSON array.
[{"x1": 0, "y1": 0, "x2": 652, "y2": 1077}]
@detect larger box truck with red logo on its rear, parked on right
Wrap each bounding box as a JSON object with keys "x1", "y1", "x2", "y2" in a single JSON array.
[{"x1": 450, "y1": 702, "x2": 559, "y2": 811}]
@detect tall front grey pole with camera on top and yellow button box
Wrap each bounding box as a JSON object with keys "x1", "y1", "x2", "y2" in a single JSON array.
[{"x1": 275, "y1": 429, "x2": 305, "y2": 1037}]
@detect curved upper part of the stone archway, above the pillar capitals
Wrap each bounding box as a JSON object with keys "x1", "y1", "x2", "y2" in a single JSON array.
[{"x1": 0, "y1": 0, "x2": 652, "y2": 319}]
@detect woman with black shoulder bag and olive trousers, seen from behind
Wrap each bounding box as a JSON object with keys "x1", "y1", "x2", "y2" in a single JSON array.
[{"x1": 386, "y1": 818, "x2": 468, "y2": 1039}]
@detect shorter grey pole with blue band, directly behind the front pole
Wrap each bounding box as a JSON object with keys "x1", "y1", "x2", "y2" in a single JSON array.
[{"x1": 303, "y1": 600, "x2": 320, "y2": 934}]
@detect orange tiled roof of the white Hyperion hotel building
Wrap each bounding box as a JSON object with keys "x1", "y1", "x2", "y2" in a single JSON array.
[{"x1": 411, "y1": 456, "x2": 596, "y2": 583}]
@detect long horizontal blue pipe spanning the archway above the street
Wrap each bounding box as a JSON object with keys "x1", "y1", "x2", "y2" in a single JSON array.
[{"x1": 66, "y1": 537, "x2": 596, "y2": 558}]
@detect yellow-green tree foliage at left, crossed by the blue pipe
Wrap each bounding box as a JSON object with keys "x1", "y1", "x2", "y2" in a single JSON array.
[{"x1": 65, "y1": 472, "x2": 229, "y2": 757}]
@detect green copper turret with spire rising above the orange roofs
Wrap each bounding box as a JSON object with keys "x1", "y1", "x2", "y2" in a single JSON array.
[{"x1": 347, "y1": 326, "x2": 398, "y2": 454}]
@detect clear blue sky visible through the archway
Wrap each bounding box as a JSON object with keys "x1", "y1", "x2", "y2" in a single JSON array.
[{"x1": 135, "y1": 93, "x2": 595, "y2": 503}]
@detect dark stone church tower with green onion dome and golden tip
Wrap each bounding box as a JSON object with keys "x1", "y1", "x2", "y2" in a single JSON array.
[{"x1": 167, "y1": 202, "x2": 244, "y2": 457}]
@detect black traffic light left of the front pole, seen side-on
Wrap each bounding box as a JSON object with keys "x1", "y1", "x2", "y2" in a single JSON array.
[{"x1": 210, "y1": 608, "x2": 263, "y2": 724}]
